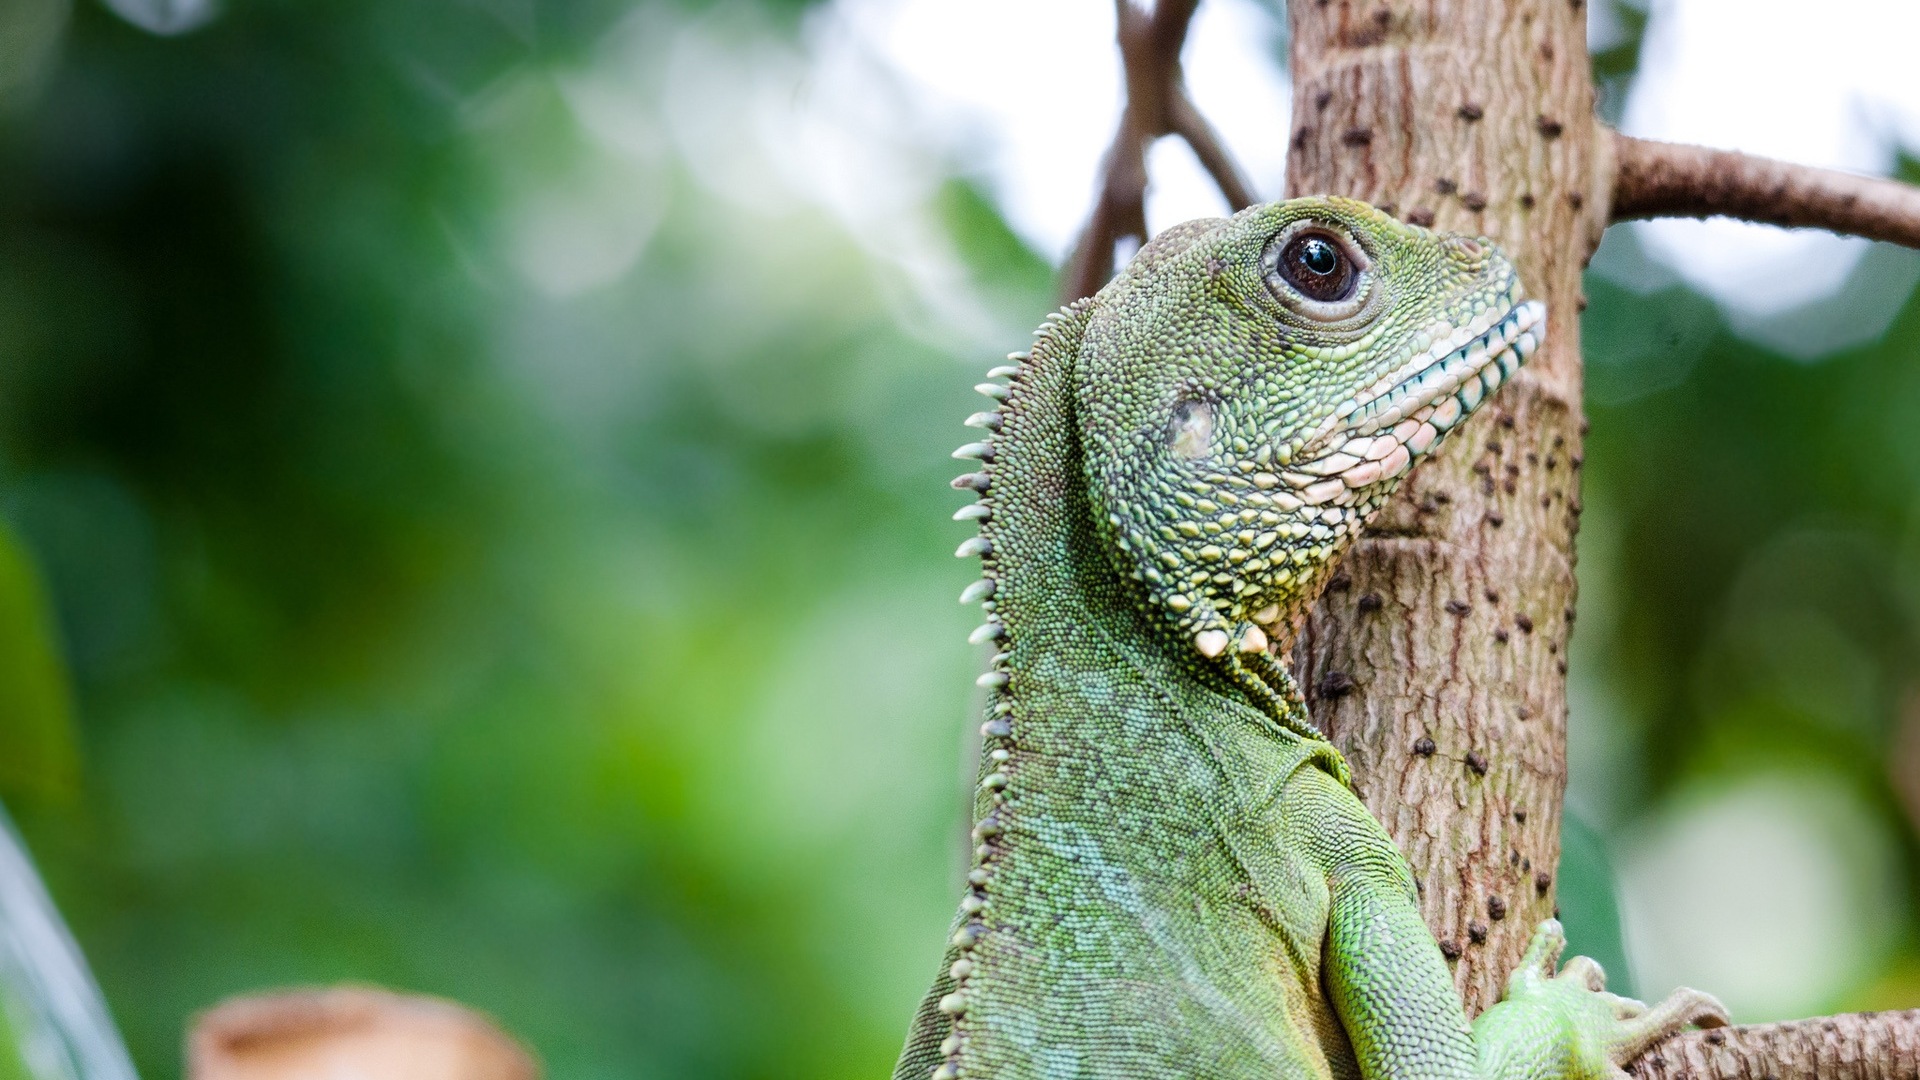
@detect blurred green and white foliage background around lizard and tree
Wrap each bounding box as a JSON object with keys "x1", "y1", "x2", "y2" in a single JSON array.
[{"x1": 0, "y1": 0, "x2": 1920, "y2": 1078}]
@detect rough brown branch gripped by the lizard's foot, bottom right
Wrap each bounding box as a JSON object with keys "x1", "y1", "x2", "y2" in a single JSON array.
[{"x1": 1628, "y1": 1009, "x2": 1920, "y2": 1080}]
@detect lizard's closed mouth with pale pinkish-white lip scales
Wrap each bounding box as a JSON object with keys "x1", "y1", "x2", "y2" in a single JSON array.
[{"x1": 1284, "y1": 292, "x2": 1548, "y2": 505}]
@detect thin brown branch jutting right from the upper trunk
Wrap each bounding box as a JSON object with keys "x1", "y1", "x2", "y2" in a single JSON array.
[{"x1": 1611, "y1": 131, "x2": 1920, "y2": 248}]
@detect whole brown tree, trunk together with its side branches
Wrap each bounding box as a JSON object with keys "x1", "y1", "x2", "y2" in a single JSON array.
[{"x1": 1068, "y1": 0, "x2": 1920, "y2": 1080}]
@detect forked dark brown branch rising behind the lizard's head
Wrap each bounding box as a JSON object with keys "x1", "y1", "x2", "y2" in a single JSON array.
[{"x1": 1062, "y1": 0, "x2": 1254, "y2": 300}]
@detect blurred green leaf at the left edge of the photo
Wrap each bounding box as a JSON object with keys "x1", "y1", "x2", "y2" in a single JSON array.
[{"x1": 0, "y1": 521, "x2": 79, "y2": 796}]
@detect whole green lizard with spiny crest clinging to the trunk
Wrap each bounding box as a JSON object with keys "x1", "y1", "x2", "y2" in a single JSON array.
[{"x1": 895, "y1": 198, "x2": 1726, "y2": 1080}]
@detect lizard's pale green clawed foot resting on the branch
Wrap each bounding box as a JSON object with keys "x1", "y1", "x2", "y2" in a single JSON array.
[{"x1": 1475, "y1": 919, "x2": 1728, "y2": 1080}]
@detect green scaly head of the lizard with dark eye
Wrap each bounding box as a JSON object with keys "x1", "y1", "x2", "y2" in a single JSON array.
[{"x1": 1075, "y1": 198, "x2": 1546, "y2": 657}]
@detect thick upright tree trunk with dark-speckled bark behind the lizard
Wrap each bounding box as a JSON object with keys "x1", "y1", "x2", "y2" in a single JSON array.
[{"x1": 1286, "y1": 0, "x2": 1611, "y2": 1013}]
